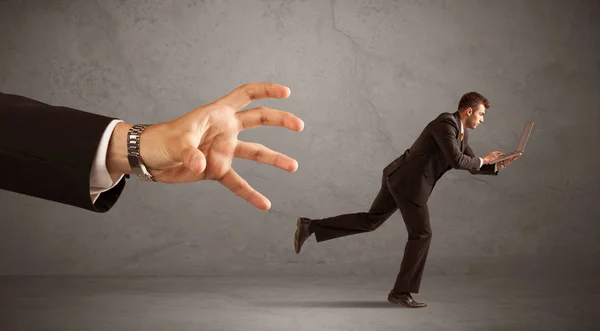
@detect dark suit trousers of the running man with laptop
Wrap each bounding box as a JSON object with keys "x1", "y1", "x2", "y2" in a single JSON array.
[{"x1": 312, "y1": 174, "x2": 431, "y2": 293}]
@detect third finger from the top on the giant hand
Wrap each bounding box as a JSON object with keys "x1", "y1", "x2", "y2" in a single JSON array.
[{"x1": 234, "y1": 141, "x2": 298, "y2": 172}]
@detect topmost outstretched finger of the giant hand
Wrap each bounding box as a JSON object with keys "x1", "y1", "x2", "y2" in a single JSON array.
[{"x1": 217, "y1": 83, "x2": 291, "y2": 111}]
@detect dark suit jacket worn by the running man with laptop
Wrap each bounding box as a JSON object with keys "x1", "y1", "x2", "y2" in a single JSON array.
[{"x1": 383, "y1": 112, "x2": 498, "y2": 206}]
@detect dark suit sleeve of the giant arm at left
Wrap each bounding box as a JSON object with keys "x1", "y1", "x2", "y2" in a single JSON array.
[{"x1": 0, "y1": 93, "x2": 125, "y2": 212}]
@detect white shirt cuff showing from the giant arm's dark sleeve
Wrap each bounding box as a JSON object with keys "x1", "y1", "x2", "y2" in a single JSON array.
[{"x1": 90, "y1": 120, "x2": 123, "y2": 203}]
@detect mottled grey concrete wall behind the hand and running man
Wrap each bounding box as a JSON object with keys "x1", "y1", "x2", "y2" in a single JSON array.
[{"x1": 0, "y1": 0, "x2": 600, "y2": 277}]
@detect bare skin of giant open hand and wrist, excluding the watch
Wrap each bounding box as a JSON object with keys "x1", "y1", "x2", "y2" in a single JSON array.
[{"x1": 107, "y1": 83, "x2": 304, "y2": 210}]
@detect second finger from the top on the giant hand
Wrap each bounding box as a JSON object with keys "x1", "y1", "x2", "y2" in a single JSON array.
[{"x1": 236, "y1": 107, "x2": 304, "y2": 131}]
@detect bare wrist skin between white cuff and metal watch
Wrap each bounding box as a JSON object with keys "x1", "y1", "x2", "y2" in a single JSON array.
[{"x1": 106, "y1": 122, "x2": 133, "y2": 176}]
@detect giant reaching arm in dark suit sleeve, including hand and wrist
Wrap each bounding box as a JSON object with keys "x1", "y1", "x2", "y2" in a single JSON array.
[{"x1": 0, "y1": 82, "x2": 304, "y2": 212}]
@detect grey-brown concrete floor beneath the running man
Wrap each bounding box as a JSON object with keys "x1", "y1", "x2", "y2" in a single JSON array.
[{"x1": 0, "y1": 276, "x2": 600, "y2": 331}]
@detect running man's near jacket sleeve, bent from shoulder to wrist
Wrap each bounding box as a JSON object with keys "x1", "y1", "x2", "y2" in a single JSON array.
[{"x1": 432, "y1": 118, "x2": 480, "y2": 170}]
